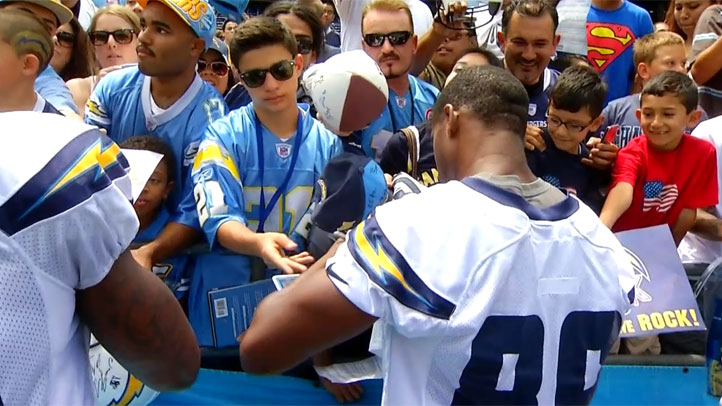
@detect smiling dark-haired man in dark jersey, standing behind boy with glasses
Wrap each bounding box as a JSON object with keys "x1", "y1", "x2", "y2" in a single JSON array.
[{"x1": 499, "y1": 0, "x2": 618, "y2": 168}]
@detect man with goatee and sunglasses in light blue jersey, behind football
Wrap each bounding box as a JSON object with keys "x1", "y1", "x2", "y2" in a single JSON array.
[{"x1": 344, "y1": 0, "x2": 439, "y2": 156}]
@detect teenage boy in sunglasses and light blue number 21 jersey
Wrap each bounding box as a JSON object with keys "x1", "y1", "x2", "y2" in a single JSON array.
[{"x1": 188, "y1": 17, "x2": 343, "y2": 346}]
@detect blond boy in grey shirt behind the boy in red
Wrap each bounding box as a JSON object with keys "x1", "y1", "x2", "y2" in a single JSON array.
[{"x1": 601, "y1": 31, "x2": 707, "y2": 148}]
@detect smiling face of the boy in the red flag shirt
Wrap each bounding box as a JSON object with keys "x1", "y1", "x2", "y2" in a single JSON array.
[{"x1": 637, "y1": 94, "x2": 700, "y2": 151}]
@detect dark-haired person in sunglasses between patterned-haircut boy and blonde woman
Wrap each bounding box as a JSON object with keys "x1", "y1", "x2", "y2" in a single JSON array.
[{"x1": 50, "y1": 17, "x2": 95, "y2": 82}]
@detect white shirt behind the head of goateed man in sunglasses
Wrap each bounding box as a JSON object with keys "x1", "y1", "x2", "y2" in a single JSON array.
[{"x1": 333, "y1": 0, "x2": 434, "y2": 52}]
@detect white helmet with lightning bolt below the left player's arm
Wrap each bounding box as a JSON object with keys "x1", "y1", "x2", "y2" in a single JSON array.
[{"x1": 89, "y1": 336, "x2": 159, "y2": 406}]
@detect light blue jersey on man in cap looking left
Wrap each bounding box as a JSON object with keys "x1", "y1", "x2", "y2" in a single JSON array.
[{"x1": 85, "y1": 65, "x2": 226, "y2": 227}]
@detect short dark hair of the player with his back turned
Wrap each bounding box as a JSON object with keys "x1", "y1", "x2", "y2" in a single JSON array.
[{"x1": 432, "y1": 65, "x2": 529, "y2": 139}]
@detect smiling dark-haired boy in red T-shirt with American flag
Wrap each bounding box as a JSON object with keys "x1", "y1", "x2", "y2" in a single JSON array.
[{"x1": 600, "y1": 72, "x2": 718, "y2": 245}]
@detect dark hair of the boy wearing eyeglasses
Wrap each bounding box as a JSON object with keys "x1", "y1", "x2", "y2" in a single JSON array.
[{"x1": 549, "y1": 65, "x2": 607, "y2": 118}]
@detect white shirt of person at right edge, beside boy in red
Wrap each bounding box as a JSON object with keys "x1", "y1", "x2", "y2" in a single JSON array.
[{"x1": 677, "y1": 116, "x2": 722, "y2": 264}]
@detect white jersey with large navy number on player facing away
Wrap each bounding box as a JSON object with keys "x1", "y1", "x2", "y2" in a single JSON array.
[{"x1": 327, "y1": 177, "x2": 634, "y2": 405}]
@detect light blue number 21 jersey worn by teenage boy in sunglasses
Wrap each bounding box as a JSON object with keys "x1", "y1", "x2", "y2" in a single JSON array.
[{"x1": 189, "y1": 103, "x2": 342, "y2": 346}]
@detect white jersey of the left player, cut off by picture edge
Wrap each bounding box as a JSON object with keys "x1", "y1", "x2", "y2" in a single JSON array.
[{"x1": 0, "y1": 112, "x2": 138, "y2": 405}]
